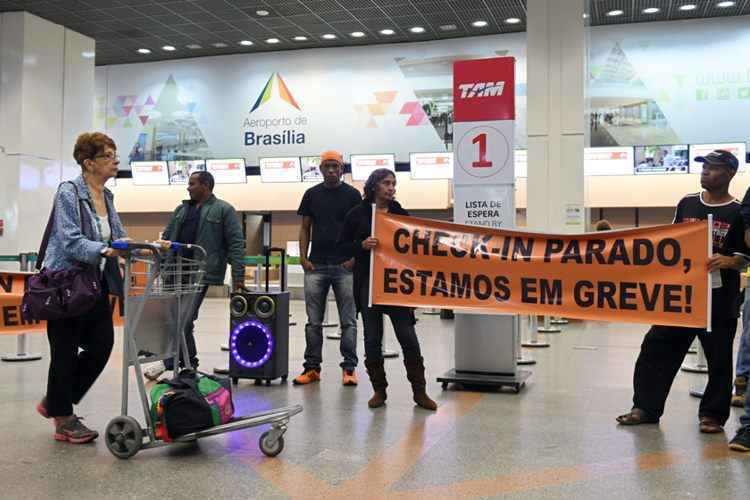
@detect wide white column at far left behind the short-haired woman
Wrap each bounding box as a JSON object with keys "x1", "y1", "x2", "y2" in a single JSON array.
[{"x1": 0, "y1": 12, "x2": 95, "y2": 270}]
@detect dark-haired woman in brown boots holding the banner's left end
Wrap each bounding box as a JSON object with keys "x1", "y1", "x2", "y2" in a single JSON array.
[{"x1": 339, "y1": 168, "x2": 437, "y2": 410}]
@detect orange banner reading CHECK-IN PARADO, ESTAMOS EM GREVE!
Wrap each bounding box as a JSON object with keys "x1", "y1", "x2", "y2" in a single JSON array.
[{"x1": 370, "y1": 212, "x2": 710, "y2": 328}]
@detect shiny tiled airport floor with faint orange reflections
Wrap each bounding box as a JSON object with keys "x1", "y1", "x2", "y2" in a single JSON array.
[{"x1": 0, "y1": 299, "x2": 750, "y2": 500}]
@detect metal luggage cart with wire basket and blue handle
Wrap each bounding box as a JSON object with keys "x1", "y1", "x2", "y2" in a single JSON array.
[{"x1": 104, "y1": 242, "x2": 302, "y2": 458}]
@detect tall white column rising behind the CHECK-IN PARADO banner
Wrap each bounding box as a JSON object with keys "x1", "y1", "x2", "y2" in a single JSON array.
[{"x1": 527, "y1": 0, "x2": 586, "y2": 233}]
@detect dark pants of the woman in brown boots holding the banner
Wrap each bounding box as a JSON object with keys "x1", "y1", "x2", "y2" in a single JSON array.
[{"x1": 360, "y1": 289, "x2": 422, "y2": 361}]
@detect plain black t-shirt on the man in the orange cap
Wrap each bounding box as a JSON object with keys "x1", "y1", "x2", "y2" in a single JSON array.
[{"x1": 297, "y1": 182, "x2": 362, "y2": 264}]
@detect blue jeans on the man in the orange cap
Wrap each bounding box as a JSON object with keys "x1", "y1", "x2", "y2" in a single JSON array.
[{"x1": 303, "y1": 264, "x2": 358, "y2": 370}]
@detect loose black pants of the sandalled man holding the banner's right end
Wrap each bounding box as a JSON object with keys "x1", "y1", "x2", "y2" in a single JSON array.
[{"x1": 633, "y1": 318, "x2": 737, "y2": 424}]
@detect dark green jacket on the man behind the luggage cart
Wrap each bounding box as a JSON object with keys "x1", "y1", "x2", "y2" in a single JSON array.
[{"x1": 162, "y1": 195, "x2": 245, "y2": 285}]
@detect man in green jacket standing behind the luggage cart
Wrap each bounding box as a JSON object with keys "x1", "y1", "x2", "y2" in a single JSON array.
[{"x1": 145, "y1": 172, "x2": 245, "y2": 380}]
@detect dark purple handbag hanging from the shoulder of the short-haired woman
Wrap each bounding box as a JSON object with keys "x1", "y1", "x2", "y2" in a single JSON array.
[{"x1": 21, "y1": 181, "x2": 102, "y2": 321}]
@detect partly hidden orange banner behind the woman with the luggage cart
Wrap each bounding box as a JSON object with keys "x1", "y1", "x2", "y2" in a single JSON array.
[{"x1": 0, "y1": 272, "x2": 124, "y2": 335}]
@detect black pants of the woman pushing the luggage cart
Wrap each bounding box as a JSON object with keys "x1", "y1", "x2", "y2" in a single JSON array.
[{"x1": 47, "y1": 280, "x2": 115, "y2": 417}]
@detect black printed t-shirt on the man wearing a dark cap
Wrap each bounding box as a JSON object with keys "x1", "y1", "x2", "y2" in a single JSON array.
[{"x1": 674, "y1": 193, "x2": 750, "y2": 318}]
